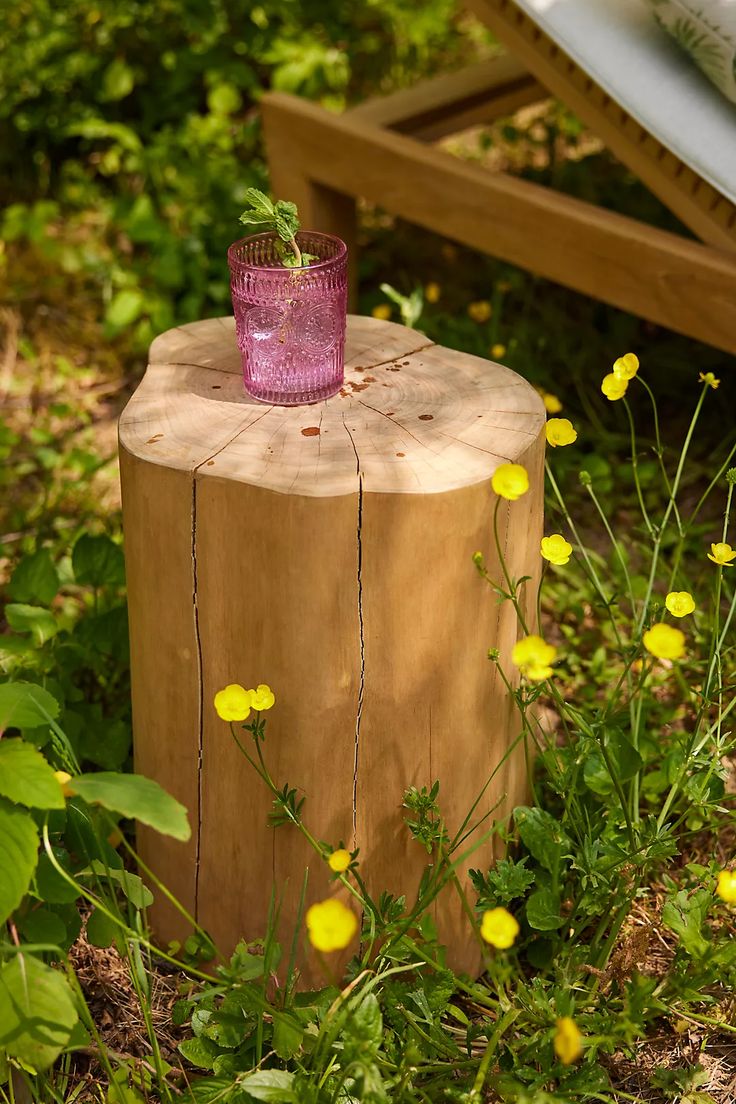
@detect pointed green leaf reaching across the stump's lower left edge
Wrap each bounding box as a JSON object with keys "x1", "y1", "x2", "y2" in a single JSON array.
[{"x1": 68, "y1": 771, "x2": 192, "y2": 840}]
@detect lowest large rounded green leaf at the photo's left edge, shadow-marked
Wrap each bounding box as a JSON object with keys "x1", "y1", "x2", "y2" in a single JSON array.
[{"x1": 0, "y1": 954, "x2": 77, "y2": 1072}]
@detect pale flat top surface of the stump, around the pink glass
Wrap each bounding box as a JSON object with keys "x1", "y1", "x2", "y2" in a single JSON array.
[{"x1": 119, "y1": 316, "x2": 545, "y2": 497}]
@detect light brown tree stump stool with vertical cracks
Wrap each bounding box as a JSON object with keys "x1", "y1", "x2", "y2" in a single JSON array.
[{"x1": 119, "y1": 317, "x2": 544, "y2": 976}]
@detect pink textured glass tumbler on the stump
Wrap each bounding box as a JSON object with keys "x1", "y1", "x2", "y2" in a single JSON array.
[{"x1": 227, "y1": 231, "x2": 348, "y2": 406}]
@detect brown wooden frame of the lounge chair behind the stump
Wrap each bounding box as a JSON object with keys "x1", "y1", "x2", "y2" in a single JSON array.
[{"x1": 262, "y1": 0, "x2": 736, "y2": 352}]
